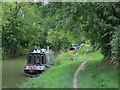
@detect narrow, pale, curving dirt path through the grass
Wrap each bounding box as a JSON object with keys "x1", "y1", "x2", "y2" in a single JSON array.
[{"x1": 73, "y1": 49, "x2": 91, "y2": 88}]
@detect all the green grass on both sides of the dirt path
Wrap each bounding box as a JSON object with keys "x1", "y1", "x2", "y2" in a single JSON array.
[{"x1": 21, "y1": 46, "x2": 118, "y2": 88}]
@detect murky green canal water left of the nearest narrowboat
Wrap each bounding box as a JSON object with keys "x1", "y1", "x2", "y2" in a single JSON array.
[{"x1": 2, "y1": 57, "x2": 28, "y2": 88}]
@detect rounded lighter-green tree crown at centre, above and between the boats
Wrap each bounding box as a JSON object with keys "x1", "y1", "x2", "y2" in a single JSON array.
[{"x1": 47, "y1": 28, "x2": 73, "y2": 50}]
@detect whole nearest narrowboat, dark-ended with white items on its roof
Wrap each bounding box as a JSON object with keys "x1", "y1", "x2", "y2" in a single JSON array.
[{"x1": 24, "y1": 46, "x2": 53, "y2": 76}]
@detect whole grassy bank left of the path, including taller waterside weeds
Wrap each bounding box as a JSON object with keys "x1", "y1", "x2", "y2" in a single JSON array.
[{"x1": 21, "y1": 47, "x2": 88, "y2": 88}]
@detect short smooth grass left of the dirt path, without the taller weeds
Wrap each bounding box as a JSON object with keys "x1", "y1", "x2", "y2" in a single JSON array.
[{"x1": 23, "y1": 62, "x2": 79, "y2": 88}]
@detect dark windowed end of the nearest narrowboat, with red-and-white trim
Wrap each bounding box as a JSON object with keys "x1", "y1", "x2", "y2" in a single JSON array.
[{"x1": 24, "y1": 53, "x2": 46, "y2": 76}]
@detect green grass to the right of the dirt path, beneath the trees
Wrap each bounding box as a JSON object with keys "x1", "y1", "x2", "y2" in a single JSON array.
[{"x1": 77, "y1": 51, "x2": 118, "y2": 88}]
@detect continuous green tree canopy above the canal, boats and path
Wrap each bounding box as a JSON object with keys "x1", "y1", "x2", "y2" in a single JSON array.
[{"x1": 2, "y1": 2, "x2": 120, "y2": 63}]
